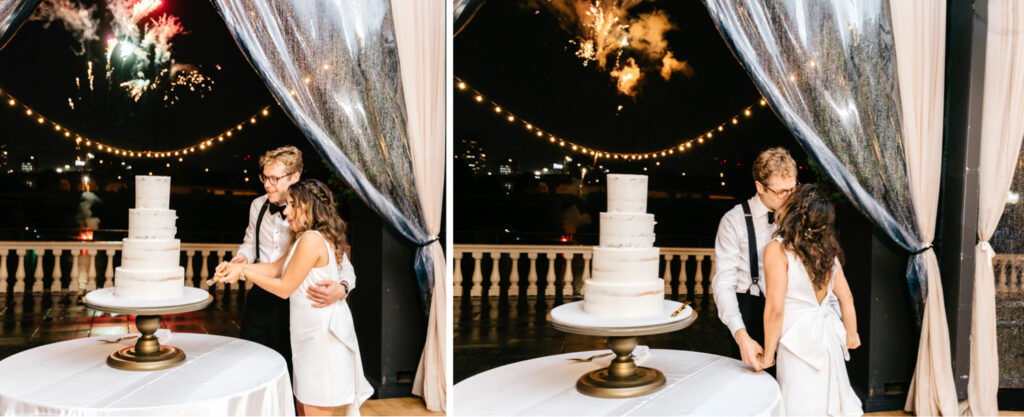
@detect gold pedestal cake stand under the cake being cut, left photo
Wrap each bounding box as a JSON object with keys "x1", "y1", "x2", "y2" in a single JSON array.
[{"x1": 82, "y1": 287, "x2": 213, "y2": 371}]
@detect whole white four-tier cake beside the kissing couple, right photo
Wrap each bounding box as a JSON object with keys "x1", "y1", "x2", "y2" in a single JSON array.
[{"x1": 583, "y1": 174, "x2": 665, "y2": 318}]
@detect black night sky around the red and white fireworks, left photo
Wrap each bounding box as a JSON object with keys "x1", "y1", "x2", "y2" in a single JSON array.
[{"x1": 0, "y1": 0, "x2": 318, "y2": 180}]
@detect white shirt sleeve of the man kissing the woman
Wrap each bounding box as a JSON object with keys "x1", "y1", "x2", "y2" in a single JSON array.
[{"x1": 711, "y1": 212, "x2": 746, "y2": 336}]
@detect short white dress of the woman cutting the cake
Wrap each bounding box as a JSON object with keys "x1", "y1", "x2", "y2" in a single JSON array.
[{"x1": 285, "y1": 231, "x2": 374, "y2": 415}]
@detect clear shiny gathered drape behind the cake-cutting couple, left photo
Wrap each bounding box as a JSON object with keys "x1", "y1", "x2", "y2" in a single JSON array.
[{"x1": 214, "y1": 0, "x2": 436, "y2": 312}]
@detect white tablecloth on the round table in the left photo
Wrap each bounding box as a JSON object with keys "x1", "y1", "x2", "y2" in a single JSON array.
[{"x1": 0, "y1": 333, "x2": 295, "y2": 415}]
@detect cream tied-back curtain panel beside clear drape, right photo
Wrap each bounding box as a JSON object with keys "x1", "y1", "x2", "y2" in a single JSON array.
[{"x1": 889, "y1": 0, "x2": 958, "y2": 416}]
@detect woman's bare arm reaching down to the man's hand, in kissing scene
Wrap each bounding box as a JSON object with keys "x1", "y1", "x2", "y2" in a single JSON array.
[{"x1": 762, "y1": 241, "x2": 790, "y2": 365}]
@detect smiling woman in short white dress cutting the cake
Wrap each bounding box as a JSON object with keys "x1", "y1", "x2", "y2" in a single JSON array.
[{"x1": 217, "y1": 179, "x2": 373, "y2": 416}]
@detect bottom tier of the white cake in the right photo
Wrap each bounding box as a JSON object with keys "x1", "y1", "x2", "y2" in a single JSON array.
[{"x1": 583, "y1": 278, "x2": 665, "y2": 318}]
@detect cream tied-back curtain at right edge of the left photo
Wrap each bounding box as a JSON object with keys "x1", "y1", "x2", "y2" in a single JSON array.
[{"x1": 391, "y1": 0, "x2": 451, "y2": 411}]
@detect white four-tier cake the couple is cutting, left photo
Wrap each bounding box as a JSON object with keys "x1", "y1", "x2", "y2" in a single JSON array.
[{"x1": 114, "y1": 175, "x2": 185, "y2": 300}]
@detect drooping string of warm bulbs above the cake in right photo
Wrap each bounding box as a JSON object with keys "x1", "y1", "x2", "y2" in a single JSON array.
[{"x1": 454, "y1": 77, "x2": 768, "y2": 161}]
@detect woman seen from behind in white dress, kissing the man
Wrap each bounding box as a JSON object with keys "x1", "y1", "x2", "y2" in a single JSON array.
[{"x1": 761, "y1": 184, "x2": 863, "y2": 416}]
